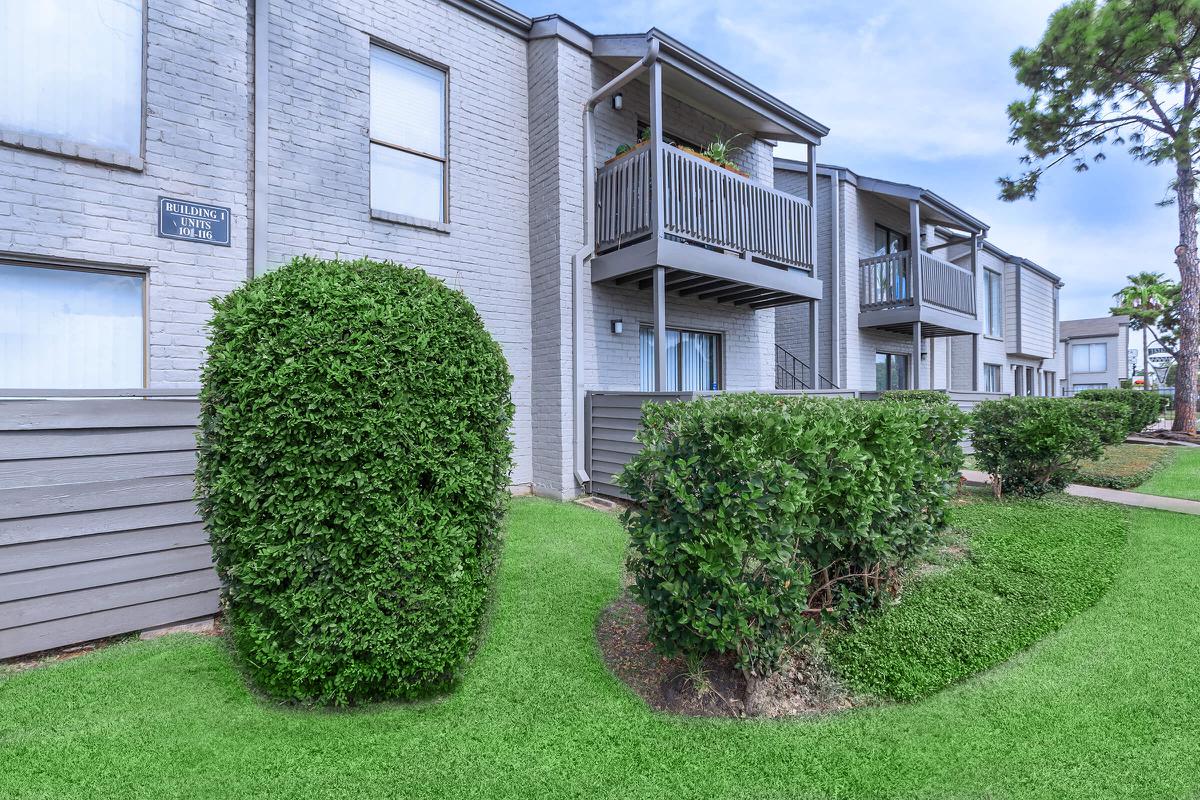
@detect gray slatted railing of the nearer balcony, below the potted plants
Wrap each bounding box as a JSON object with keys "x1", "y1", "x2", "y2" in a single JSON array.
[{"x1": 595, "y1": 145, "x2": 812, "y2": 270}]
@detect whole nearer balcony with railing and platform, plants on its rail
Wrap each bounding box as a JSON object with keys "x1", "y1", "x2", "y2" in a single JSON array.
[{"x1": 592, "y1": 143, "x2": 821, "y2": 308}]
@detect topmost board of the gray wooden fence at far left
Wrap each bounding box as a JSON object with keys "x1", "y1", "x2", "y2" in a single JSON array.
[{"x1": 0, "y1": 398, "x2": 200, "y2": 431}]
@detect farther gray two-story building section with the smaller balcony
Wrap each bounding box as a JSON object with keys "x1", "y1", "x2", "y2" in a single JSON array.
[{"x1": 775, "y1": 160, "x2": 1062, "y2": 395}]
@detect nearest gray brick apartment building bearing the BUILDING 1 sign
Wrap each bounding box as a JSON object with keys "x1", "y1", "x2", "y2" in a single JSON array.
[{"x1": 0, "y1": 0, "x2": 827, "y2": 497}]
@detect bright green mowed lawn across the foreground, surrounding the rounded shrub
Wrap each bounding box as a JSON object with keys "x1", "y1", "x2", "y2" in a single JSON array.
[{"x1": 0, "y1": 500, "x2": 1200, "y2": 800}]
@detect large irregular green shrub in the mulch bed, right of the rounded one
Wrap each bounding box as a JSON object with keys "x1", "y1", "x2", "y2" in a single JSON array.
[{"x1": 619, "y1": 395, "x2": 962, "y2": 674}]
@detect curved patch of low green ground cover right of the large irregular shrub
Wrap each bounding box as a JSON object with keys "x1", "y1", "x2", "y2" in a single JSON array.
[{"x1": 827, "y1": 497, "x2": 1127, "y2": 700}]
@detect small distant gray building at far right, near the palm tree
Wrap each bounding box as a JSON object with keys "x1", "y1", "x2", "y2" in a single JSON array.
[{"x1": 1056, "y1": 315, "x2": 1129, "y2": 393}]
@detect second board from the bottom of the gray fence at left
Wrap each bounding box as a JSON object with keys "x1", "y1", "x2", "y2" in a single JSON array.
[{"x1": 0, "y1": 570, "x2": 221, "y2": 630}]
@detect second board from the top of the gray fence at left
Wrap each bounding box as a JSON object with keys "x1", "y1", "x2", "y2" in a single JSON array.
[{"x1": 0, "y1": 424, "x2": 196, "y2": 462}]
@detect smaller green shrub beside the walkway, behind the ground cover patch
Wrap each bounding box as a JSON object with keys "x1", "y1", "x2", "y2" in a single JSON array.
[{"x1": 971, "y1": 397, "x2": 1103, "y2": 495}]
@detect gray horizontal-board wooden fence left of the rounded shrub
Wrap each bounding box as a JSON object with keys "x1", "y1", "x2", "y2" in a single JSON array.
[{"x1": 0, "y1": 390, "x2": 220, "y2": 658}]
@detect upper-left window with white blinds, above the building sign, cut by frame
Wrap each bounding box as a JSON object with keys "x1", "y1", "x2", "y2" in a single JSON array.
[{"x1": 0, "y1": 0, "x2": 143, "y2": 155}]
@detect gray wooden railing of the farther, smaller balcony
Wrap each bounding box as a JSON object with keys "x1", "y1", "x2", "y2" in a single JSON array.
[{"x1": 858, "y1": 251, "x2": 976, "y2": 317}]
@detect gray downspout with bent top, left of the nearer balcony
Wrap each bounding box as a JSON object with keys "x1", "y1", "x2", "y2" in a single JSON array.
[{"x1": 568, "y1": 38, "x2": 659, "y2": 486}]
